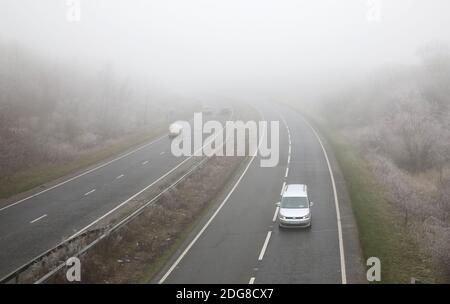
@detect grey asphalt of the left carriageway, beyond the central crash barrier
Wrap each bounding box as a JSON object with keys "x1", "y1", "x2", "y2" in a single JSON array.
[{"x1": 0, "y1": 111, "x2": 228, "y2": 278}]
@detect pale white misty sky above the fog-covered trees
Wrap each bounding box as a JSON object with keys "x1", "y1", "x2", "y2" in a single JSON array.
[{"x1": 0, "y1": 0, "x2": 450, "y2": 95}]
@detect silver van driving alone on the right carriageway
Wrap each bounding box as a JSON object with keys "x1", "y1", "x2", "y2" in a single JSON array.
[{"x1": 277, "y1": 184, "x2": 313, "y2": 227}]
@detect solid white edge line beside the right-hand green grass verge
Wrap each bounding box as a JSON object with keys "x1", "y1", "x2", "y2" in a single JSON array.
[{"x1": 302, "y1": 116, "x2": 347, "y2": 284}]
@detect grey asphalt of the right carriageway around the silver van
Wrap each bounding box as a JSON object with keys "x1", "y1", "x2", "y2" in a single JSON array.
[{"x1": 155, "y1": 104, "x2": 363, "y2": 283}]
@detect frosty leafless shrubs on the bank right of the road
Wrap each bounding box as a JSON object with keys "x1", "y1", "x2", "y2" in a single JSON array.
[{"x1": 322, "y1": 42, "x2": 450, "y2": 277}]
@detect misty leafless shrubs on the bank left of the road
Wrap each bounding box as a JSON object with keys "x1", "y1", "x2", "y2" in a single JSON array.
[{"x1": 0, "y1": 44, "x2": 192, "y2": 183}]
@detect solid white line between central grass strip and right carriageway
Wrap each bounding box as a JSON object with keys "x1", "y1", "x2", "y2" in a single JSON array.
[{"x1": 158, "y1": 112, "x2": 266, "y2": 284}]
